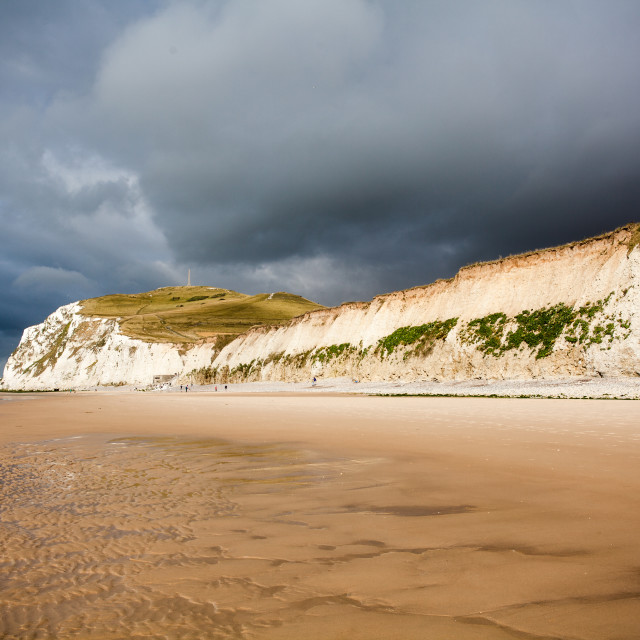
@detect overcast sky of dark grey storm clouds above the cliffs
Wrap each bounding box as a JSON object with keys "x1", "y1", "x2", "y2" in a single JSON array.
[{"x1": 0, "y1": 0, "x2": 640, "y2": 367}]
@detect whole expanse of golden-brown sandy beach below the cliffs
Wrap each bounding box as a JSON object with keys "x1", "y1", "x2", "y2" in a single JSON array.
[{"x1": 0, "y1": 393, "x2": 640, "y2": 640}]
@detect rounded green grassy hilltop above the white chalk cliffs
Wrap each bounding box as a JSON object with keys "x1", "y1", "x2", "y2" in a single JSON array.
[{"x1": 82, "y1": 287, "x2": 322, "y2": 343}]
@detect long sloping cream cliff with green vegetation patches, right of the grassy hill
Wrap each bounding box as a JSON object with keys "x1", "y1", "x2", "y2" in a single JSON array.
[{"x1": 199, "y1": 225, "x2": 640, "y2": 381}]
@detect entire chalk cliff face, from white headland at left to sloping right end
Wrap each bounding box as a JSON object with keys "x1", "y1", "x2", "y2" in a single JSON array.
[{"x1": 4, "y1": 225, "x2": 640, "y2": 388}]
